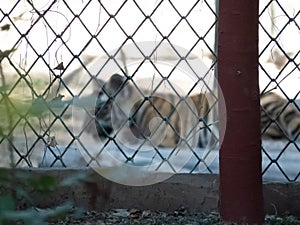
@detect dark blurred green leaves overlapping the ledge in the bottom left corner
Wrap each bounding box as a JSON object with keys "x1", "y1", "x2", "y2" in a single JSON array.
[{"x1": 0, "y1": 169, "x2": 81, "y2": 225}]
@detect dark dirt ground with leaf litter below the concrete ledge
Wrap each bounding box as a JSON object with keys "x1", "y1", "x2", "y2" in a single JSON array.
[{"x1": 50, "y1": 208, "x2": 300, "y2": 225}]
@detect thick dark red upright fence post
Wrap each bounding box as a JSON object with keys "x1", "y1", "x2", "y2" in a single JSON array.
[{"x1": 218, "y1": 0, "x2": 264, "y2": 224}]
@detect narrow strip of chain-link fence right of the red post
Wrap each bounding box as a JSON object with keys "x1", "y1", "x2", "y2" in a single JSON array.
[{"x1": 259, "y1": 1, "x2": 300, "y2": 181}]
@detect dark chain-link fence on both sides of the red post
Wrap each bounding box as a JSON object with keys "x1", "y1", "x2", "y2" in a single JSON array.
[{"x1": 0, "y1": 0, "x2": 300, "y2": 181}]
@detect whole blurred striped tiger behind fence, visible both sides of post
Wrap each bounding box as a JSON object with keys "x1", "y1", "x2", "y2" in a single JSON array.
[{"x1": 95, "y1": 74, "x2": 300, "y2": 147}]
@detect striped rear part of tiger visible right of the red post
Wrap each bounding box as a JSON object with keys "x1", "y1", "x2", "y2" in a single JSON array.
[{"x1": 260, "y1": 92, "x2": 300, "y2": 140}]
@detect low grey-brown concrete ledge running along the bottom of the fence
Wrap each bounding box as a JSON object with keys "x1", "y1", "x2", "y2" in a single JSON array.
[{"x1": 0, "y1": 169, "x2": 300, "y2": 217}]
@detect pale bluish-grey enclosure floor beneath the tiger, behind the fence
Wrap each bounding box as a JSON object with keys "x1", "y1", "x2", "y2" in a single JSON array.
[{"x1": 40, "y1": 140, "x2": 300, "y2": 182}]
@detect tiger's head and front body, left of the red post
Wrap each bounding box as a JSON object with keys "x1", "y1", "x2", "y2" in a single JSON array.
[{"x1": 95, "y1": 74, "x2": 210, "y2": 148}]
